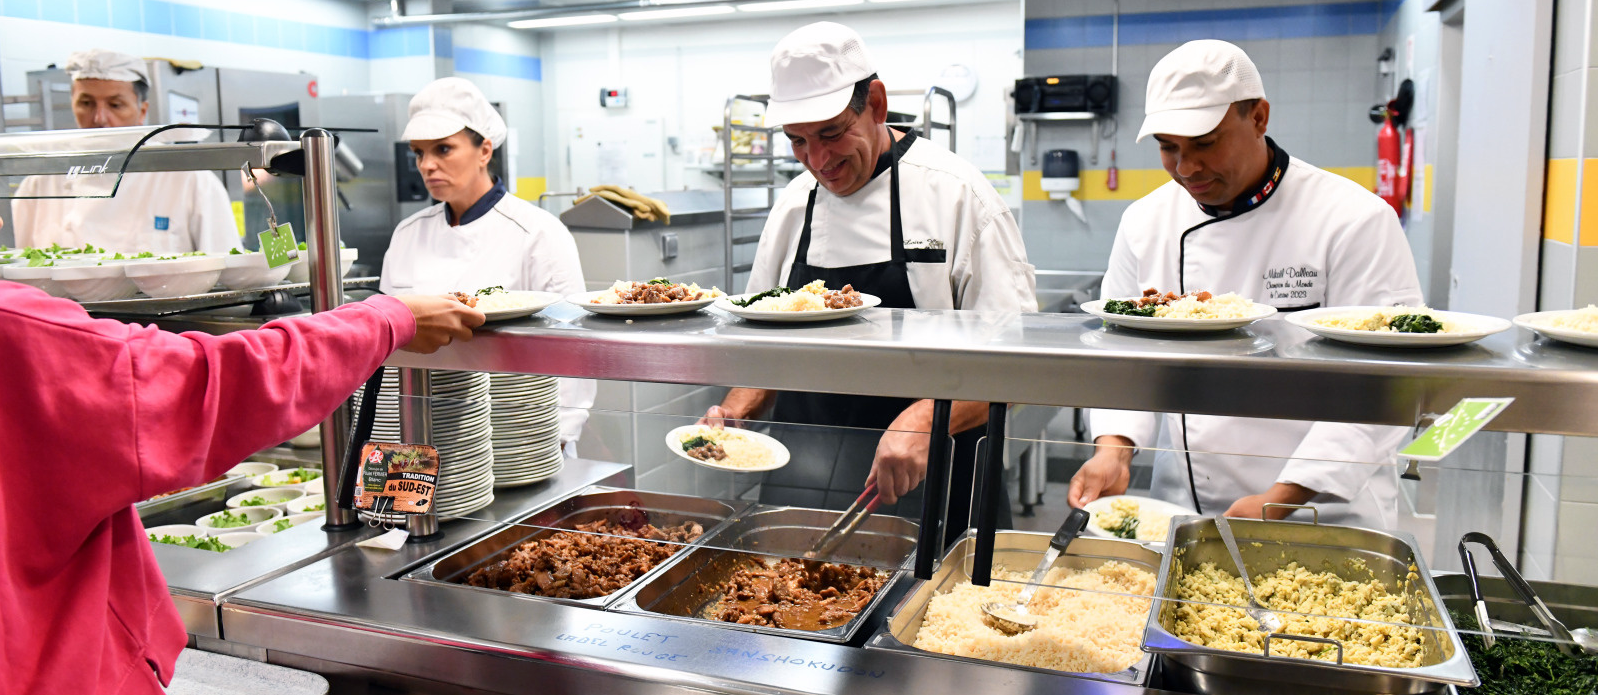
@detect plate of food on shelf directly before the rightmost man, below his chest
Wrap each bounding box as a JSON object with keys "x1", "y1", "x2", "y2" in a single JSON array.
[{"x1": 1082, "y1": 288, "x2": 1277, "y2": 332}]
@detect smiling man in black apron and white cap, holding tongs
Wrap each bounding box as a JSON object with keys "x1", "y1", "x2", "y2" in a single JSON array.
[{"x1": 706, "y1": 22, "x2": 1037, "y2": 543}]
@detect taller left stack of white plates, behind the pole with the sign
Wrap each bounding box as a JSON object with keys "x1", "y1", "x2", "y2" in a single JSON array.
[{"x1": 355, "y1": 367, "x2": 494, "y2": 521}]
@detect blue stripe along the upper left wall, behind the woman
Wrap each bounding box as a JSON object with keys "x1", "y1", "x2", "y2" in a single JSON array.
[{"x1": 0, "y1": 0, "x2": 543, "y2": 80}]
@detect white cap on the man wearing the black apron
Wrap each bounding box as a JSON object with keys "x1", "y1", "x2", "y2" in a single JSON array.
[{"x1": 765, "y1": 22, "x2": 877, "y2": 128}]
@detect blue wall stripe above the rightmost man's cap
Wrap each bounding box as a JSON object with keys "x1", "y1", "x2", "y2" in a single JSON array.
[{"x1": 1026, "y1": 0, "x2": 1401, "y2": 51}]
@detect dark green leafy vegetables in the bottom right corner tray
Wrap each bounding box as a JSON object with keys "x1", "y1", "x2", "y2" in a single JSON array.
[{"x1": 1449, "y1": 610, "x2": 1598, "y2": 695}]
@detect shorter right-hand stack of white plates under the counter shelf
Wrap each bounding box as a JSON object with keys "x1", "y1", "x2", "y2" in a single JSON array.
[{"x1": 489, "y1": 374, "x2": 561, "y2": 487}]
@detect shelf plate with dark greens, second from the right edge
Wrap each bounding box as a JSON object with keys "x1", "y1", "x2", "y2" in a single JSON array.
[{"x1": 1286, "y1": 307, "x2": 1510, "y2": 347}]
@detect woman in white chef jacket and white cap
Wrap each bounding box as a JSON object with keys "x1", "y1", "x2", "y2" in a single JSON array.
[{"x1": 380, "y1": 77, "x2": 598, "y2": 454}]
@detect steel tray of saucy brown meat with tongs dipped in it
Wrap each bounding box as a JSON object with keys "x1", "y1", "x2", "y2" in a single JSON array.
[{"x1": 610, "y1": 506, "x2": 916, "y2": 642}]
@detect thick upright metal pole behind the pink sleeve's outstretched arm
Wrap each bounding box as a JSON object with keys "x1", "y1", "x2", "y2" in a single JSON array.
[{"x1": 300, "y1": 128, "x2": 356, "y2": 529}]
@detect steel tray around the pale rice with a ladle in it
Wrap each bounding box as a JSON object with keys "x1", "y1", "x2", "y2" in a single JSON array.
[{"x1": 866, "y1": 530, "x2": 1160, "y2": 685}]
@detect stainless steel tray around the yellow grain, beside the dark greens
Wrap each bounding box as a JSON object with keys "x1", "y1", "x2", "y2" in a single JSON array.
[{"x1": 1143, "y1": 516, "x2": 1478, "y2": 693}]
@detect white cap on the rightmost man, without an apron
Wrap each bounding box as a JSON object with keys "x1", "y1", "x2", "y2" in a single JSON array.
[{"x1": 1138, "y1": 38, "x2": 1266, "y2": 142}]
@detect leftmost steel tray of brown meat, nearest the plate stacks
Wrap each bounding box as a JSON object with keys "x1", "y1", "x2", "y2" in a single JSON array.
[{"x1": 401, "y1": 486, "x2": 748, "y2": 609}]
